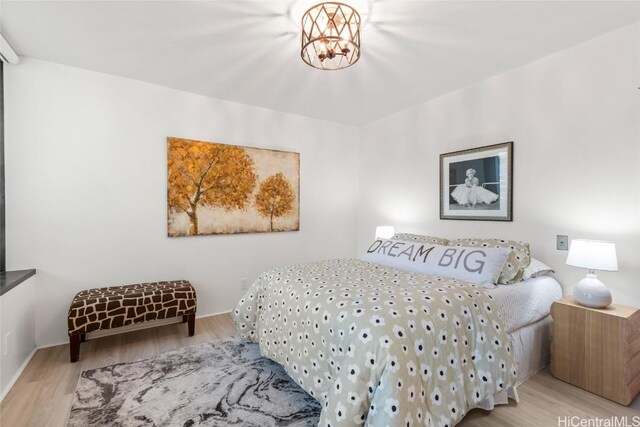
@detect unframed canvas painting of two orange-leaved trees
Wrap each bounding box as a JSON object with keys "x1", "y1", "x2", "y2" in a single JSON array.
[{"x1": 167, "y1": 138, "x2": 300, "y2": 237}]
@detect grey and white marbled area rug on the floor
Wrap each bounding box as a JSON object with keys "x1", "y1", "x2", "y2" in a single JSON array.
[{"x1": 68, "y1": 340, "x2": 320, "y2": 427}]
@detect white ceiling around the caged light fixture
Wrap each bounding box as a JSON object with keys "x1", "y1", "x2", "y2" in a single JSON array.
[{"x1": 0, "y1": 0, "x2": 640, "y2": 125}]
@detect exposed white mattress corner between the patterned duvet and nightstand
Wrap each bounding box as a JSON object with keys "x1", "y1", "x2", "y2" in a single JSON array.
[{"x1": 487, "y1": 276, "x2": 562, "y2": 333}]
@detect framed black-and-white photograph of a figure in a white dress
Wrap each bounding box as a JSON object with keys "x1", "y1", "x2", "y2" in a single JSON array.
[{"x1": 440, "y1": 142, "x2": 513, "y2": 221}]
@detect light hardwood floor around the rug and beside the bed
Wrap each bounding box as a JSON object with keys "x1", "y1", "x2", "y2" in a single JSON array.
[{"x1": 0, "y1": 314, "x2": 640, "y2": 427}]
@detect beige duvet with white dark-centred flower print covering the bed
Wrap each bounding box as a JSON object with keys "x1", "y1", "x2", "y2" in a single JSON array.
[{"x1": 232, "y1": 259, "x2": 516, "y2": 426}]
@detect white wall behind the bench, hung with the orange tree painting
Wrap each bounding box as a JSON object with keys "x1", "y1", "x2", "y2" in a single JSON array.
[{"x1": 5, "y1": 59, "x2": 358, "y2": 346}]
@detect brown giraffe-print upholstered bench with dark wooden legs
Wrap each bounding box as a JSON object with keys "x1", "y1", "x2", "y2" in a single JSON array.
[{"x1": 68, "y1": 280, "x2": 196, "y2": 362}]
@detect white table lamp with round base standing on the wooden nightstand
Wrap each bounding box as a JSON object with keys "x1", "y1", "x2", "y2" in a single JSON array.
[{"x1": 567, "y1": 239, "x2": 618, "y2": 308}]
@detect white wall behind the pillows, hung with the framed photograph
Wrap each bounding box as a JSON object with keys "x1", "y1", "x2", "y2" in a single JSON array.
[{"x1": 358, "y1": 24, "x2": 640, "y2": 306}]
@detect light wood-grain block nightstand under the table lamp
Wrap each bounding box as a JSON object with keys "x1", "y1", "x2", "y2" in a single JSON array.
[{"x1": 551, "y1": 296, "x2": 640, "y2": 406}]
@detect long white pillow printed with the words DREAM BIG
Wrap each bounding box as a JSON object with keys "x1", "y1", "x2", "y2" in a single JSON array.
[{"x1": 362, "y1": 239, "x2": 511, "y2": 287}]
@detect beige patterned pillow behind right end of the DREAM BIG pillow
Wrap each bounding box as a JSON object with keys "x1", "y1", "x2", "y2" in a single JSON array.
[{"x1": 449, "y1": 239, "x2": 531, "y2": 285}]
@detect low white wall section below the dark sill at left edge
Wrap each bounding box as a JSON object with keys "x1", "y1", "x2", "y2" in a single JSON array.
[{"x1": 0, "y1": 276, "x2": 38, "y2": 400}]
